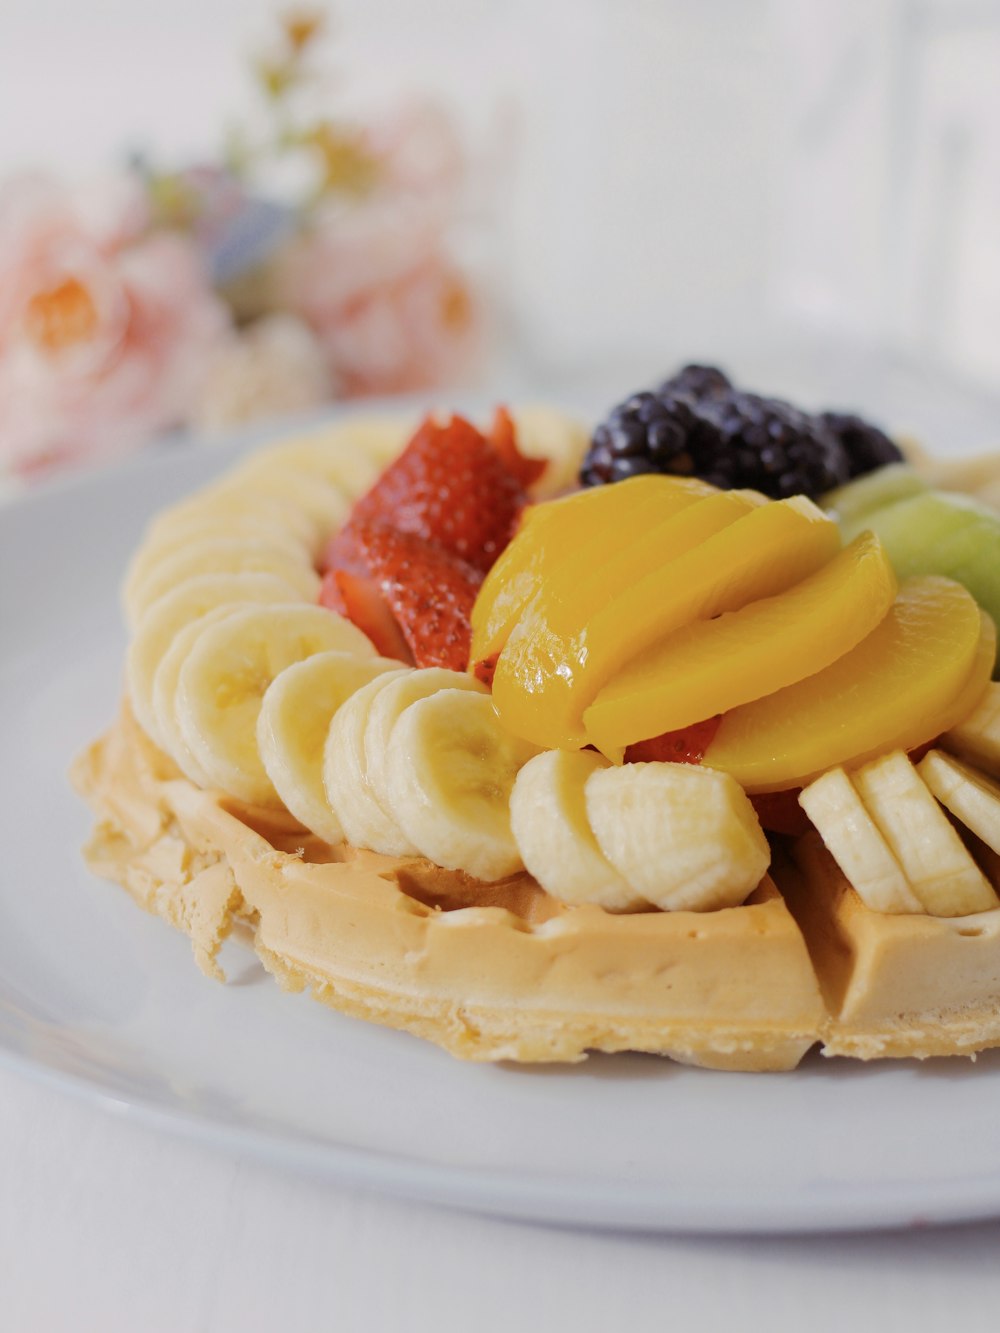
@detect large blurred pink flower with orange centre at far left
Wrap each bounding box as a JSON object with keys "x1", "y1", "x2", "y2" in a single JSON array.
[{"x1": 0, "y1": 169, "x2": 228, "y2": 473}]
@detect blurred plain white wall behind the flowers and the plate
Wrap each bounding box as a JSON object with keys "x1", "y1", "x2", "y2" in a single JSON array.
[{"x1": 0, "y1": 0, "x2": 1000, "y2": 381}]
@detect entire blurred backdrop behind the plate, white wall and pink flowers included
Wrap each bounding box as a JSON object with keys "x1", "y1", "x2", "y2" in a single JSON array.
[{"x1": 0, "y1": 0, "x2": 1000, "y2": 487}]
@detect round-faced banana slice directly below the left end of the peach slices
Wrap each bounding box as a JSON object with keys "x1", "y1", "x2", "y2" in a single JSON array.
[{"x1": 385, "y1": 689, "x2": 539, "y2": 880}]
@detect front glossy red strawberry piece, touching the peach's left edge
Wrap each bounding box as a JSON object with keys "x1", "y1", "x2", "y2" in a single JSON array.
[{"x1": 320, "y1": 520, "x2": 483, "y2": 672}]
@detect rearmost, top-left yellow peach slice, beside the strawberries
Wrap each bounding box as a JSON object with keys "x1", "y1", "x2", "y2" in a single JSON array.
[{"x1": 469, "y1": 475, "x2": 716, "y2": 667}]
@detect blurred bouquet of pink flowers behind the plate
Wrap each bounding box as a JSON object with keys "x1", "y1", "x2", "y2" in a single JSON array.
[{"x1": 0, "y1": 13, "x2": 483, "y2": 485}]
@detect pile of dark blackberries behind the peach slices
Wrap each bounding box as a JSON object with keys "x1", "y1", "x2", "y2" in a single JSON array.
[{"x1": 580, "y1": 365, "x2": 899, "y2": 500}]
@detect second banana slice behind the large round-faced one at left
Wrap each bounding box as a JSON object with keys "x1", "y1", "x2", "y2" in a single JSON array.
[{"x1": 125, "y1": 573, "x2": 301, "y2": 753}]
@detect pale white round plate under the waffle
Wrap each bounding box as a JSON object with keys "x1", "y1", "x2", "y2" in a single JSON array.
[{"x1": 0, "y1": 418, "x2": 1000, "y2": 1232}]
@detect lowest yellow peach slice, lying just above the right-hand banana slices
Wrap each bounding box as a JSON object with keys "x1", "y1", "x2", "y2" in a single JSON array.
[{"x1": 704, "y1": 576, "x2": 996, "y2": 792}]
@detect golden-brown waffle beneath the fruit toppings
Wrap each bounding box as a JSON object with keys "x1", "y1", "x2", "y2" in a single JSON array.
[{"x1": 73, "y1": 709, "x2": 1000, "y2": 1070}]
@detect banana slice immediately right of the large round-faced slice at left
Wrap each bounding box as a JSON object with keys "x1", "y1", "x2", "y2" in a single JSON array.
[{"x1": 257, "y1": 652, "x2": 399, "y2": 842}]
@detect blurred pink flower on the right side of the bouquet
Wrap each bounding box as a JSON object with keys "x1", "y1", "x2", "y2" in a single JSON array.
[{"x1": 275, "y1": 104, "x2": 481, "y2": 396}]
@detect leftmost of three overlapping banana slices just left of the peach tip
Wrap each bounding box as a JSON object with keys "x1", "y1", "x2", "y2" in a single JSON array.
[{"x1": 323, "y1": 667, "x2": 420, "y2": 856}]
